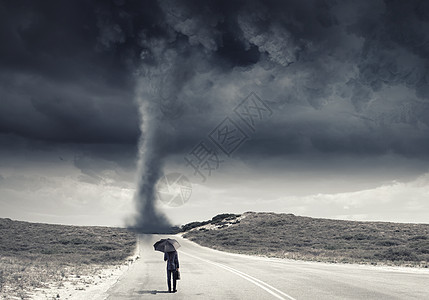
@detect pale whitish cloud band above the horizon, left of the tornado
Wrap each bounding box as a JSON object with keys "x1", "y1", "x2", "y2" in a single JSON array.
[{"x1": 0, "y1": 176, "x2": 134, "y2": 226}]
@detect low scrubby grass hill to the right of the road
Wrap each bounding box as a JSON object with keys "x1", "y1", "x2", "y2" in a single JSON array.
[{"x1": 182, "y1": 213, "x2": 429, "y2": 268}]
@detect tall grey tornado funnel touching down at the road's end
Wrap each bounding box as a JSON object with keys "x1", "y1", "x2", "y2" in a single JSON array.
[{"x1": 131, "y1": 41, "x2": 192, "y2": 233}]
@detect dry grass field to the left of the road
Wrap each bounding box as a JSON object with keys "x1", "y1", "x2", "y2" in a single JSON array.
[{"x1": 0, "y1": 219, "x2": 136, "y2": 299}]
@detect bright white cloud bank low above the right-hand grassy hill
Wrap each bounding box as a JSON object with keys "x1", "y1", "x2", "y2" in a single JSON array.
[{"x1": 273, "y1": 174, "x2": 429, "y2": 223}]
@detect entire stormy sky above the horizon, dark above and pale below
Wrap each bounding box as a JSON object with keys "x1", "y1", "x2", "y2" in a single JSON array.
[{"x1": 0, "y1": 0, "x2": 429, "y2": 226}]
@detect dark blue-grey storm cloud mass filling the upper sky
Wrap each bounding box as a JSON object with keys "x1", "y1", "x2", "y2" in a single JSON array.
[{"x1": 0, "y1": 0, "x2": 429, "y2": 225}]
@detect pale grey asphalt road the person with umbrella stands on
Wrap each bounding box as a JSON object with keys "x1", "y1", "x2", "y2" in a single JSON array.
[{"x1": 107, "y1": 235, "x2": 429, "y2": 300}]
